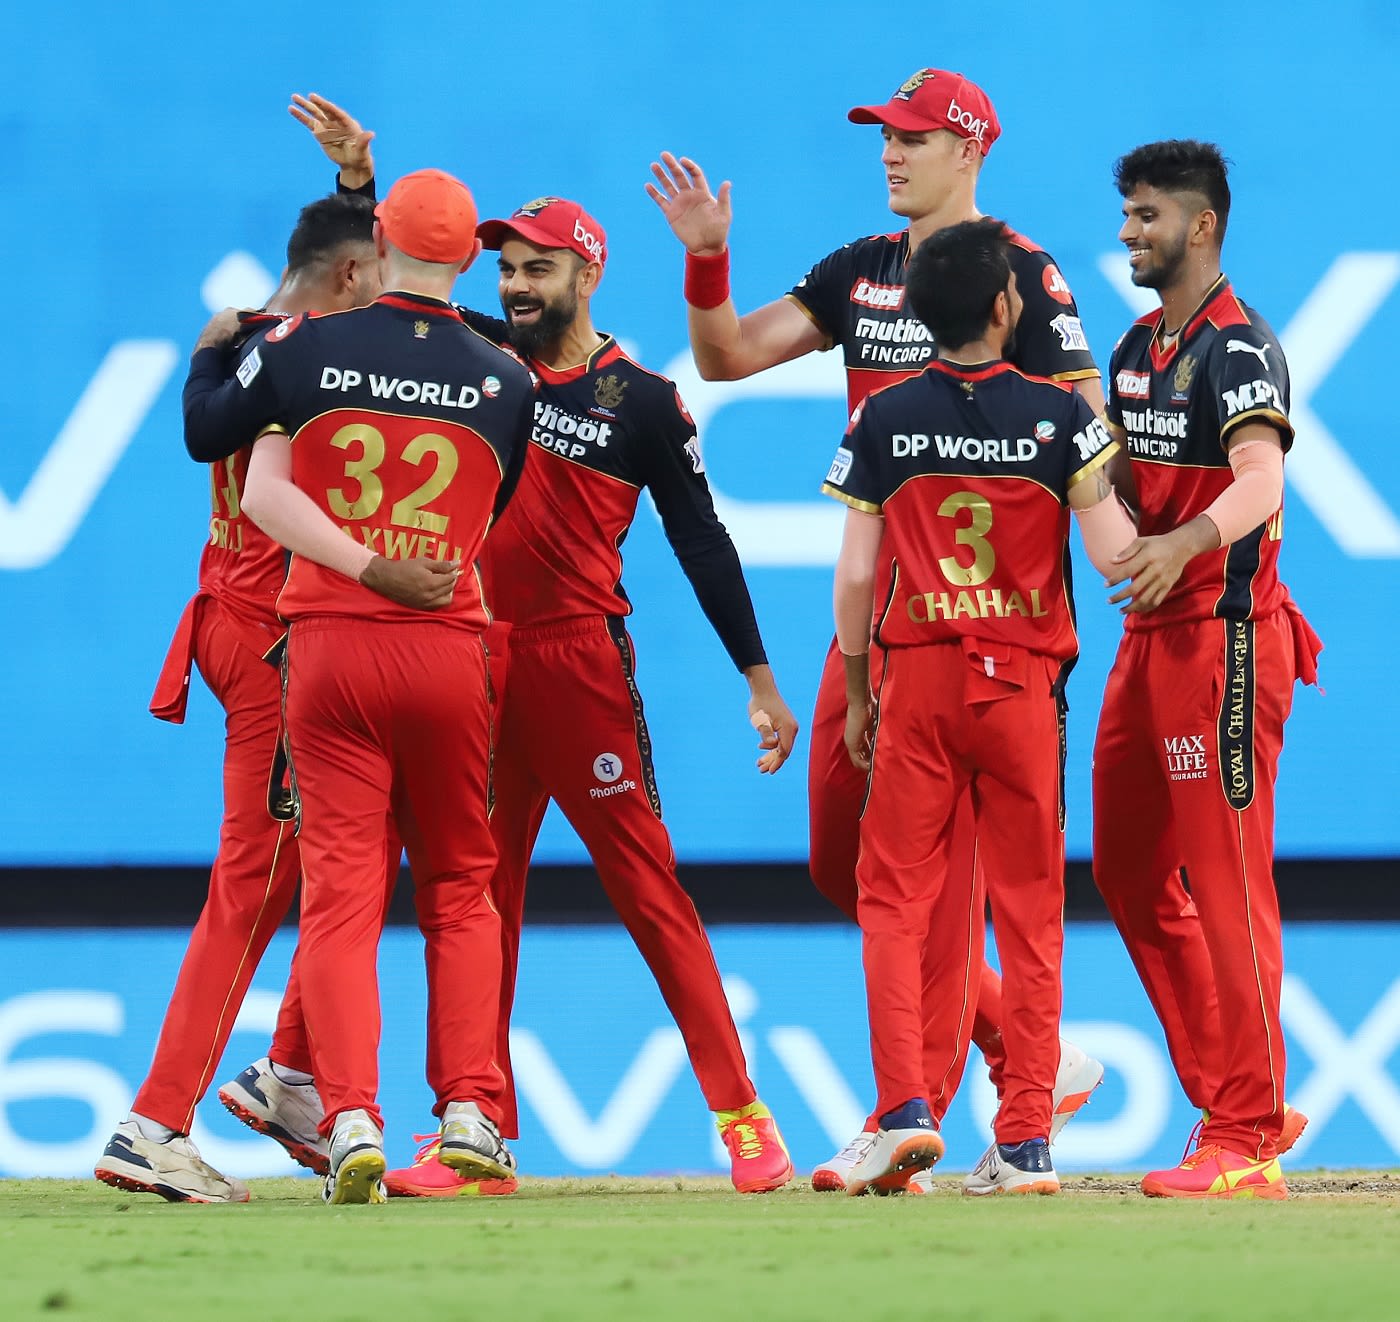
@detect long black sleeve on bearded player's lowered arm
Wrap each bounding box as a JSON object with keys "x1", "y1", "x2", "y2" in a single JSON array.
[{"x1": 638, "y1": 382, "x2": 767, "y2": 671}]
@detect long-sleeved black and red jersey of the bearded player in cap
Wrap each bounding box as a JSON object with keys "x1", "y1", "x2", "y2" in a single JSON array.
[{"x1": 461, "y1": 309, "x2": 766, "y2": 669}]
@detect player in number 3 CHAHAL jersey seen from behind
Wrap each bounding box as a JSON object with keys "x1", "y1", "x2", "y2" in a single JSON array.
[{"x1": 823, "y1": 218, "x2": 1134, "y2": 1195}]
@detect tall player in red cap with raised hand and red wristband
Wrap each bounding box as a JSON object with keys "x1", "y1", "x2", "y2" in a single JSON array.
[{"x1": 647, "y1": 69, "x2": 1120, "y2": 1190}]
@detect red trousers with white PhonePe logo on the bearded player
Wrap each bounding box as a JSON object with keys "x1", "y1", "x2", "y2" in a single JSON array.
[{"x1": 489, "y1": 616, "x2": 756, "y2": 1137}]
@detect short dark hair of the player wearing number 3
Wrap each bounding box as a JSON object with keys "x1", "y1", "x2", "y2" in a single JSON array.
[{"x1": 904, "y1": 216, "x2": 1011, "y2": 349}]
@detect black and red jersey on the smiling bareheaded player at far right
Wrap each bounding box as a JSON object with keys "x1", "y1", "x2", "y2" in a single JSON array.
[{"x1": 1107, "y1": 276, "x2": 1294, "y2": 629}]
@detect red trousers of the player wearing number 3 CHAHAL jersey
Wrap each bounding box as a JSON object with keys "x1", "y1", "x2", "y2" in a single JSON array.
[{"x1": 857, "y1": 639, "x2": 1064, "y2": 1143}]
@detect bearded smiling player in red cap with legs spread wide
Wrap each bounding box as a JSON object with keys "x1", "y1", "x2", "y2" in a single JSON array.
[{"x1": 388, "y1": 197, "x2": 797, "y2": 1195}]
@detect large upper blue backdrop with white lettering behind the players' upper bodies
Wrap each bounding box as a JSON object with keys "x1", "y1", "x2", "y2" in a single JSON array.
[{"x1": 0, "y1": 0, "x2": 1400, "y2": 865}]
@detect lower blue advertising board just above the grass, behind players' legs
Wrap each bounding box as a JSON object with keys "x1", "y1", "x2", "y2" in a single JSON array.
[{"x1": 0, "y1": 924, "x2": 1400, "y2": 1176}]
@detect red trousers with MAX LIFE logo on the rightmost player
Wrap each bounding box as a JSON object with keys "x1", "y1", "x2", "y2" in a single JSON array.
[{"x1": 1093, "y1": 602, "x2": 1320, "y2": 1160}]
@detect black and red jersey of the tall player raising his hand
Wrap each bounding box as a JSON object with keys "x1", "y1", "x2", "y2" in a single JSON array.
[{"x1": 787, "y1": 230, "x2": 1099, "y2": 412}]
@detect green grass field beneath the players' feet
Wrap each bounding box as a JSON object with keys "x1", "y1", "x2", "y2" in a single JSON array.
[{"x1": 0, "y1": 1172, "x2": 1400, "y2": 1322}]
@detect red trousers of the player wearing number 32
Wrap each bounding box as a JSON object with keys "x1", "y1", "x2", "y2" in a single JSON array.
[{"x1": 287, "y1": 616, "x2": 503, "y2": 1134}]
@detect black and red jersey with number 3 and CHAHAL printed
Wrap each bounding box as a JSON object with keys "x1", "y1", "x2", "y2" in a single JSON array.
[{"x1": 822, "y1": 360, "x2": 1117, "y2": 661}]
